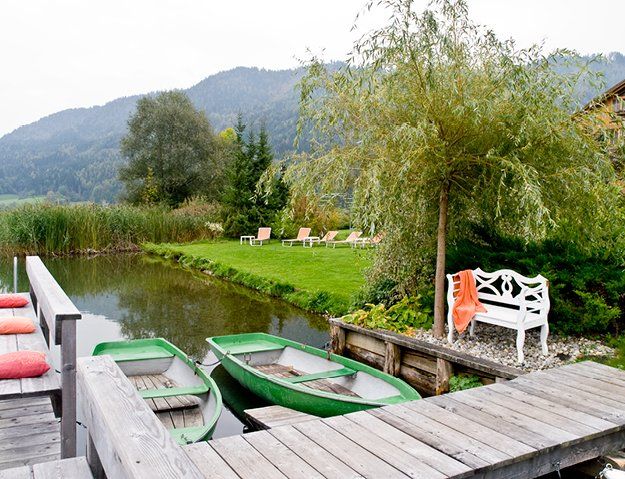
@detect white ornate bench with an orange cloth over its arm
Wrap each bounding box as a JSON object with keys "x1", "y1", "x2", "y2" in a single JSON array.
[{"x1": 447, "y1": 268, "x2": 549, "y2": 363}]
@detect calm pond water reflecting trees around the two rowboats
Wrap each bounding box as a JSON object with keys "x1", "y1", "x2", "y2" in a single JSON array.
[{"x1": 0, "y1": 255, "x2": 329, "y2": 438}]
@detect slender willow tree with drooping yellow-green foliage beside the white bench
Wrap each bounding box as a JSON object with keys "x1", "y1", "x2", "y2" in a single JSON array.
[{"x1": 287, "y1": 0, "x2": 618, "y2": 337}]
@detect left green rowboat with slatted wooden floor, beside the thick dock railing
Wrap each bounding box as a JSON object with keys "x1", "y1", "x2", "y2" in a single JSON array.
[{"x1": 93, "y1": 338, "x2": 222, "y2": 444}]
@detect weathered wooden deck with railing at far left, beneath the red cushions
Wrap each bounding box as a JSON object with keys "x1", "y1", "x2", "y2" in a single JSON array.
[{"x1": 0, "y1": 256, "x2": 81, "y2": 477}]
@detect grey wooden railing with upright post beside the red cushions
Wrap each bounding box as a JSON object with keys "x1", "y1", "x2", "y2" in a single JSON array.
[{"x1": 26, "y1": 256, "x2": 82, "y2": 458}]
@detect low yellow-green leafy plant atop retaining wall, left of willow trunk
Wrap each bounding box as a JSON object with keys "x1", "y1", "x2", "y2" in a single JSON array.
[{"x1": 342, "y1": 295, "x2": 432, "y2": 334}]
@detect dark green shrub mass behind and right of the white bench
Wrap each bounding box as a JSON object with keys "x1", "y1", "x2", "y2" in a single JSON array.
[{"x1": 447, "y1": 230, "x2": 625, "y2": 335}]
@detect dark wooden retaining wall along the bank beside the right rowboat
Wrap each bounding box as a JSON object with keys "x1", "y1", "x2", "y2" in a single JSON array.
[{"x1": 330, "y1": 319, "x2": 524, "y2": 396}]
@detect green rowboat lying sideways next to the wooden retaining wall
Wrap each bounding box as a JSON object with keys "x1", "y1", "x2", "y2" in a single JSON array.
[{"x1": 207, "y1": 333, "x2": 421, "y2": 417}]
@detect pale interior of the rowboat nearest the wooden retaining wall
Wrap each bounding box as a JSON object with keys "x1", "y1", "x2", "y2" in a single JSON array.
[{"x1": 234, "y1": 342, "x2": 401, "y2": 400}]
